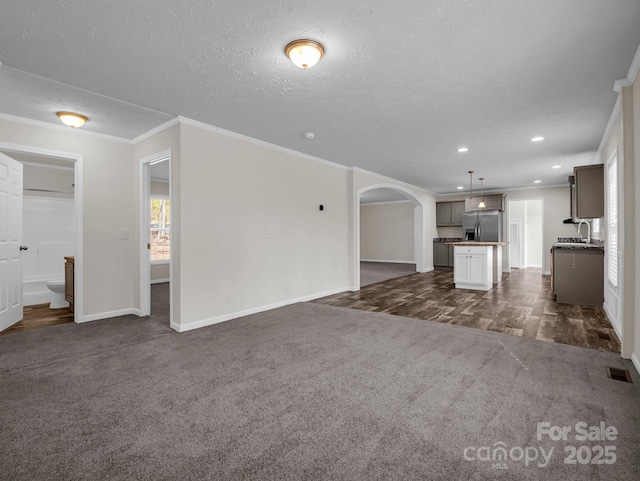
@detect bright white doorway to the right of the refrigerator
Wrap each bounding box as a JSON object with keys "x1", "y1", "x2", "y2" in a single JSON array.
[{"x1": 508, "y1": 199, "x2": 544, "y2": 269}]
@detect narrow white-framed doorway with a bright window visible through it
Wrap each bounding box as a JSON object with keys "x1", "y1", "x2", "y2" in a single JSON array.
[{"x1": 140, "y1": 151, "x2": 172, "y2": 320}]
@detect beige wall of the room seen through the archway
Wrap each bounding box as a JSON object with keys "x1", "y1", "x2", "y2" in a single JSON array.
[{"x1": 360, "y1": 201, "x2": 415, "y2": 263}]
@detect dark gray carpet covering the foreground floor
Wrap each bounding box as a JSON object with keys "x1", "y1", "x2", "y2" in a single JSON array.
[{"x1": 0, "y1": 284, "x2": 640, "y2": 481}]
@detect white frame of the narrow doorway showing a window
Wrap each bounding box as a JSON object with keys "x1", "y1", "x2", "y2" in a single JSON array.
[{"x1": 138, "y1": 149, "x2": 175, "y2": 324}]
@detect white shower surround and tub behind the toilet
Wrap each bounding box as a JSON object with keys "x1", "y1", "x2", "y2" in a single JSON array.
[{"x1": 22, "y1": 196, "x2": 75, "y2": 306}]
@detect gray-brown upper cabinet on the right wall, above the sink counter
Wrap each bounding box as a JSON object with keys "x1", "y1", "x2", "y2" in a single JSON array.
[{"x1": 573, "y1": 164, "x2": 604, "y2": 219}]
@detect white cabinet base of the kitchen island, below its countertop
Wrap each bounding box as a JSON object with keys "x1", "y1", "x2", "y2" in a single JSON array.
[{"x1": 453, "y1": 245, "x2": 494, "y2": 291}]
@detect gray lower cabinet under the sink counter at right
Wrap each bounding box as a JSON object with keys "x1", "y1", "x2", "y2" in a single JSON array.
[{"x1": 553, "y1": 248, "x2": 604, "y2": 307}]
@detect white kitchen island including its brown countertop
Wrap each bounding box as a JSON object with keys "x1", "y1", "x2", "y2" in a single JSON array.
[{"x1": 449, "y1": 241, "x2": 506, "y2": 291}]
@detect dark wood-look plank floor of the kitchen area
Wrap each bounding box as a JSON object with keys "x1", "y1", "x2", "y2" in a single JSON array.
[{"x1": 312, "y1": 268, "x2": 620, "y2": 352}]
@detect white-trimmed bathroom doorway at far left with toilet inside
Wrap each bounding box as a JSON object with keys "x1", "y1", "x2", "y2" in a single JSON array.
[{"x1": 0, "y1": 143, "x2": 83, "y2": 330}]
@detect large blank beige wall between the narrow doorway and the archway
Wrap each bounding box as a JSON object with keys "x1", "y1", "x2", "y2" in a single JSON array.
[{"x1": 172, "y1": 124, "x2": 349, "y2": 330}]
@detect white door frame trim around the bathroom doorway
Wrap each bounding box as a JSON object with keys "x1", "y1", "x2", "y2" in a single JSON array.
[{"x1": 0, "y1": 142, "x2": 84, "y2": 323}]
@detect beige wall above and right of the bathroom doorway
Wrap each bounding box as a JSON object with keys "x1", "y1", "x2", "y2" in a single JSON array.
[{"x1": 0, "y1": 119, "x2": 136, "y2": 320}]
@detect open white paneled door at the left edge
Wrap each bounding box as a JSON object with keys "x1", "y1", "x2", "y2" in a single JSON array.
[{"x1": 0, "y1": 154, "x2": 22, "y2": 331}]
